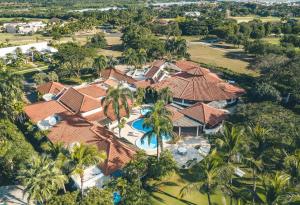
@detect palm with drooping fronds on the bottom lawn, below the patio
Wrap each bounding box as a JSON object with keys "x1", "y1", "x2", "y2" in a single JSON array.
[{"x1": 180, "y1": 150, "x2": 229, "y2": 205}]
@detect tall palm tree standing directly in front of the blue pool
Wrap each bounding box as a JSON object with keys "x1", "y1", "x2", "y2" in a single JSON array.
[{"x1": 142, "y1": 100, "x2": 174, "y2": 160}]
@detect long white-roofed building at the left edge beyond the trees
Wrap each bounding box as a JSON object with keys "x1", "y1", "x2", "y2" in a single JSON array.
[{"x1": 0, "y1": 42, "x2": 57, "y2": 58}]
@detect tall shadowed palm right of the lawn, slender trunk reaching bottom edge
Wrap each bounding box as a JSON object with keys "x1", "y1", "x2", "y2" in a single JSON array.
[{"x1": 245, "y1": 125, "x2": 272, "y2": 204}]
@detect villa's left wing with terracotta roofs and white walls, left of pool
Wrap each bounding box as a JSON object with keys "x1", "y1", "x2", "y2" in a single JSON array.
[{"x1": 24, "y1": 82, "x2": 136, "y2": 188}]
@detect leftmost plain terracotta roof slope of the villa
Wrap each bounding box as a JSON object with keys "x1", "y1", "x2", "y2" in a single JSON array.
[{"x1": 24, "y1": 100, "x2": 66, "y2": 123}]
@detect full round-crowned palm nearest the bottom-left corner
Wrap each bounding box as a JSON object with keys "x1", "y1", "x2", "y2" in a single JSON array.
[{"x1": 18, "y1": 156, "x2": 68, "y2": 204}]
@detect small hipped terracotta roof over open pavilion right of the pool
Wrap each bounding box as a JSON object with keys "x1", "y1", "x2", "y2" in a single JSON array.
[{"x1": 179, "y1": 103, "x2": 228, "y2": 126}]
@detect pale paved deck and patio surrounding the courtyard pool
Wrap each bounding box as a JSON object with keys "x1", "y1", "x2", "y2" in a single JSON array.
[{"x1": 113, "y1": 105, "x2": 210, "y2": 167}]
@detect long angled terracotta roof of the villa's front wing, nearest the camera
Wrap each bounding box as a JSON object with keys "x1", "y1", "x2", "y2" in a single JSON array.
[{"x1": 48, "y1": 112, "x2": 136, "y2": 175}]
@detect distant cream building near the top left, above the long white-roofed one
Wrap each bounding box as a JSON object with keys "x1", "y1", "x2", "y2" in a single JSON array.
[{"x1": 3, "y1": 21, "x2": 46, "y2": 34}]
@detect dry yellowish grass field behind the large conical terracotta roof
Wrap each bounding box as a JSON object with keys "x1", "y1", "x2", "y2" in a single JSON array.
[{"x1": 188, "y1": 44, "x2": 258, "y2": 76}]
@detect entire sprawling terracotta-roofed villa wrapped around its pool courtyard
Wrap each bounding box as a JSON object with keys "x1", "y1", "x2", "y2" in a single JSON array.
[{"x1": 25, "y1": 61, "x2": 245, "y2": 187}]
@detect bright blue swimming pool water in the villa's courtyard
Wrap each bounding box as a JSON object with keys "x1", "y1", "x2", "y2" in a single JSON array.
[{"x1": 132, "y1": 118, "x2": 170, "y2": 150}]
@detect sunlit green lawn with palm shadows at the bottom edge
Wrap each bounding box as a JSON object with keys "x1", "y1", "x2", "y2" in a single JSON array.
[{"x1": 151, "y1": 173, "x2": 228, "y2": 205}]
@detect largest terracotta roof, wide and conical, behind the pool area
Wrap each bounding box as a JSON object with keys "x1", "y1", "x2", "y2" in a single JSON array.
[{"x1": 153, "y1": 67, "x2": 245, "y2": 102}]
